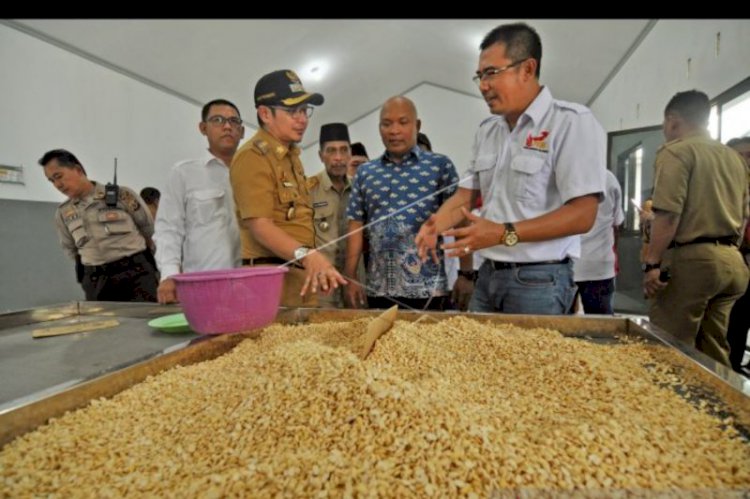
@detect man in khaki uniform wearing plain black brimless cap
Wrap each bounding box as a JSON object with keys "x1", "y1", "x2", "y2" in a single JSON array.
[{"x1": 311, "y1": 123, "x2": 364, "y2": 308}]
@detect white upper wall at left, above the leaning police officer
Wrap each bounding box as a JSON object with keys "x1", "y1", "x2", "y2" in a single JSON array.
[{"x1": 0, "y1": 25, "x2": 206, "y2": 204}]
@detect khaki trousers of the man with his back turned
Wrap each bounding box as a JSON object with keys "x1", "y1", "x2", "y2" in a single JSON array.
[{"x1": 649, "y1": 243, "x2": 750, "y2": 365}]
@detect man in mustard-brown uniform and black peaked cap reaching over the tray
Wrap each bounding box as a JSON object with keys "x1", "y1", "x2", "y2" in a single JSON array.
[{"x1": 229, "y1": 70, "x2": 346, "y2": 307}]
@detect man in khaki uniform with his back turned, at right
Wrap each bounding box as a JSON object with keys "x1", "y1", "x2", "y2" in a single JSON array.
[{"x1": 643, "y1": 90, "x2": 748, "y2": 365}]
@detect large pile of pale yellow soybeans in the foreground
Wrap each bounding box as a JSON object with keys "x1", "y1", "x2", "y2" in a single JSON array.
[{"x1": 0, "y1": 317, "x2": 750, "y2": 497}]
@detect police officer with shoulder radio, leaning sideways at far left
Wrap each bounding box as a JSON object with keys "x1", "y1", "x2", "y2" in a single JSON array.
[{"x1": 39, "y1": 149, "x2": 157, "y2": 301}]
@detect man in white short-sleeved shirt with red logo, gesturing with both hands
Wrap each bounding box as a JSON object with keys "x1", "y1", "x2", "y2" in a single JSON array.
[{"x1": 416, "y1": 23, "x2": 606, "y2": 314}]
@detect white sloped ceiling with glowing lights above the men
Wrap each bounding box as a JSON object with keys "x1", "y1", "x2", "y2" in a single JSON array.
[{"x1": 6, "y1": 19, "x2": 653, "y2": 143}]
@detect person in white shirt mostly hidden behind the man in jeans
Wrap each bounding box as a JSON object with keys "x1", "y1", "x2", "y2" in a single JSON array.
[{"x1": 573, "y1": 170, "x2": 625, "y2": 315}]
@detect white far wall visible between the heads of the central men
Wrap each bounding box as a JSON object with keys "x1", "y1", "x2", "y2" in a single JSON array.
[{"x1": 302, "y1": 84, "x2": 490, "y2": 181}]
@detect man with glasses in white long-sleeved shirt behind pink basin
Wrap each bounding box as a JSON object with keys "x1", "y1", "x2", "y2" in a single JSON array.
[{"x1": 154, "y1": 99, "x2": 245, "y2": 303}]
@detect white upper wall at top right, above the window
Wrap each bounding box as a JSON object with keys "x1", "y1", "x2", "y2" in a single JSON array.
[{"x1": 591, "y1": 19, "x2": 750, "y2": 131}]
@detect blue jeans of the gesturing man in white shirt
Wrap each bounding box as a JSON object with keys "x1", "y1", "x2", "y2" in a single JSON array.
[{"x1": 469, "y1": 261, "x2": 576, "y2": 315}]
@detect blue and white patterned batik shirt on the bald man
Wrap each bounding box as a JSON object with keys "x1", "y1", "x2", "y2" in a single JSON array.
[{"x1": 346, "y1": 146, "x2": 458, "y2": 298}]
